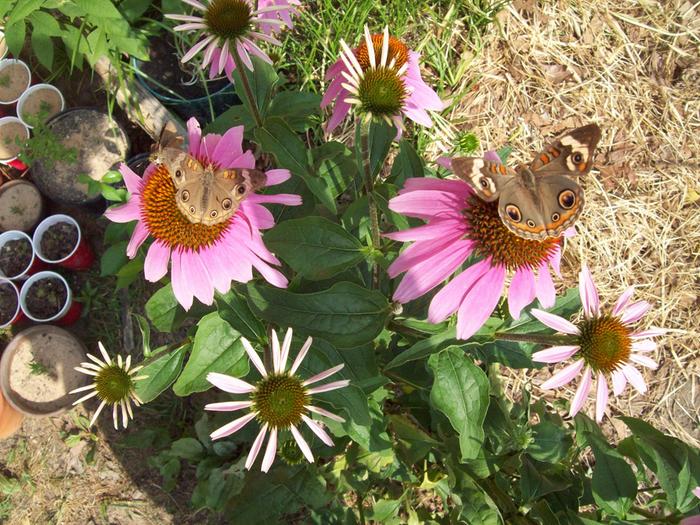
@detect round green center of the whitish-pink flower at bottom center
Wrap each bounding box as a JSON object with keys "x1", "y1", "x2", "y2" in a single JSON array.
[{"x1": 253, "y1": 374, "x2": 309, "y2": 428}]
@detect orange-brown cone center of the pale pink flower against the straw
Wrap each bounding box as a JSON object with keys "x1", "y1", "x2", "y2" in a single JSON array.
[{"x1": 578, "y1": 317, "x2": 632, "y2": 373}]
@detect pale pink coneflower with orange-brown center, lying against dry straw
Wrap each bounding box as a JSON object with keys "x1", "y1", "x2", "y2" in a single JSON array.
[{"x1": 531, "y1": 266, "x2": 666, "y2": 421}]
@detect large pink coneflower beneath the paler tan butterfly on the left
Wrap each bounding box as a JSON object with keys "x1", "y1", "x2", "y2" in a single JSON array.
[{"x1": 105, "y1": 118, "x2": 301, "y2": 310}]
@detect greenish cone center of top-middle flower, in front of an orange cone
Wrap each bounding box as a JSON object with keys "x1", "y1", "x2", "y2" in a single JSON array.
[{"x1": 358, "y1": 67, "x2": 406, "y2": 116}]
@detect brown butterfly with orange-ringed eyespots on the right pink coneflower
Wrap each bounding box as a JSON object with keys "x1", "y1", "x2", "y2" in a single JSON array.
[{"x1": 452, "y1": 124, "x2": 601, "y2": 241}]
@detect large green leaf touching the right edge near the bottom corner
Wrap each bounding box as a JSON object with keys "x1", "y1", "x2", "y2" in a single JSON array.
[{"x1": 620, "y1": 417, "x2": 700, "y2": 512}]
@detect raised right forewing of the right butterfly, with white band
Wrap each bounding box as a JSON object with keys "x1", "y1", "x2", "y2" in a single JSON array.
[{"x1": 530, "y1": 124, "x2": 601, "y2": 176}]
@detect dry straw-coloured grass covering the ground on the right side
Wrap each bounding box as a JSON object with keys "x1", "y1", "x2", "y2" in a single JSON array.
[{"x1": 440, "y1": 0, "x2": 700, "y2": 445}]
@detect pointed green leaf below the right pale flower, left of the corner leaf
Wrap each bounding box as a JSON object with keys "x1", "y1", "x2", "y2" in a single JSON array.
[{"x1": 588, "y1": 434, "x2": 637, "y2": 518}]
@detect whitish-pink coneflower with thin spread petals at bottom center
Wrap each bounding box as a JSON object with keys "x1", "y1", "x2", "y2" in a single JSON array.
[{"x1": 204, "y1": 328, "x2": 350, "y2": 472}]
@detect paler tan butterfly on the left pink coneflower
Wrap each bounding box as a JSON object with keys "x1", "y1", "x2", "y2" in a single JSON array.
[{"x1": 151, "y1": 125, "x2": 267, "y2": 226}]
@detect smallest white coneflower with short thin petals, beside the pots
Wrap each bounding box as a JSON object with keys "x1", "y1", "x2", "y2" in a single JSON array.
[{"x1": 70, "y1": 343, "x2": 148, "y2": 430}]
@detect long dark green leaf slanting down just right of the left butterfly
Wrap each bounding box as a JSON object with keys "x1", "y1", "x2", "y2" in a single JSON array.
[{"x1": 255, "y1": 118, "x2": 336, "y2": 213}]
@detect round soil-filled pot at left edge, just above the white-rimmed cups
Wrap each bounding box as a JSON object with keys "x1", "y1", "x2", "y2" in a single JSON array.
[{"x1": 0, "y1": 180, "x2": 44, "y2": 232}]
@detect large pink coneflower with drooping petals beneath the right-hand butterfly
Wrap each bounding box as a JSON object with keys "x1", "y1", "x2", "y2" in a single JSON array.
[{"x1": 385, "y1": 154, "x2": 562, "y2": 339}]
